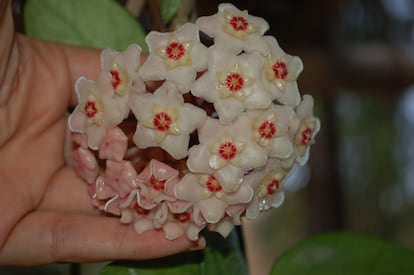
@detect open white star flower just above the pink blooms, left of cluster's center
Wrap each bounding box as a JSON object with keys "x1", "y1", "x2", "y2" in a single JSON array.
[{"x1": 130, "y1": 83, "x2": 206, "y2": 159}]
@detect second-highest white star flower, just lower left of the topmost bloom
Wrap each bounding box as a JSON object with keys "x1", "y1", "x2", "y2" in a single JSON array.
[{"x1": 139, "y1": 23, "x2": 207, "y2": 93}]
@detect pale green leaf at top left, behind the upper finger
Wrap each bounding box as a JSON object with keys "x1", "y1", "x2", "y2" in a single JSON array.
[{"x1": 24, "y1": 0, "x2": 147, "y2": 51}]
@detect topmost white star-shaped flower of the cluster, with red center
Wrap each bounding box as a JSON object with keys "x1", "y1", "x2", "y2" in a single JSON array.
[{"x1": 196, "y1": 3, "x2": 269, "y2": 55}]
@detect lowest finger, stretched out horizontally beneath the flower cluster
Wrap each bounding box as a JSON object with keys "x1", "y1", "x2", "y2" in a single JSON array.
[{"x1": 0, "y1": 211, "x2": 205, "y2": 265}]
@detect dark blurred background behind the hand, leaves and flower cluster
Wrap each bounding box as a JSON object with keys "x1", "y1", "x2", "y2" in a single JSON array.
[{"x1": 5, "y1": 0, "x2": 414, "y2": 275}]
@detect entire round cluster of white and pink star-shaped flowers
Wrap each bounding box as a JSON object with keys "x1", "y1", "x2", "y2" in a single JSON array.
[{"x1": 69, "y1": 4, "x2": 320, "y2": 240}]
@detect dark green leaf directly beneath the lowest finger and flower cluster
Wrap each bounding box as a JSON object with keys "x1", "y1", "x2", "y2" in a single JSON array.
[{"x1": 100, "y1": 232, "x2": 246, "y2": 275}]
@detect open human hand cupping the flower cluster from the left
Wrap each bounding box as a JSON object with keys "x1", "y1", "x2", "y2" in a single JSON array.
[{"x1": 0, "y1": 1, "x2": 205, "y2": 265}]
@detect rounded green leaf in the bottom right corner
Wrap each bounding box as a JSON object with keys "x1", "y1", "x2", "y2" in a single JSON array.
[{"x1": 271, "y1": 232, "x2": 414, "y2": 275}]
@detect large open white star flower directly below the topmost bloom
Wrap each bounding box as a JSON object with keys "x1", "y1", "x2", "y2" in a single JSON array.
[{"x1": 191, "y1": 47, "x2": 271, "y2": 124}]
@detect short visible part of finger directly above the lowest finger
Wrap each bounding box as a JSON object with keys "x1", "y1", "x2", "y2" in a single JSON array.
[{"x1": 38, "y1": 167, "x2": 99, "y2": 214}]
